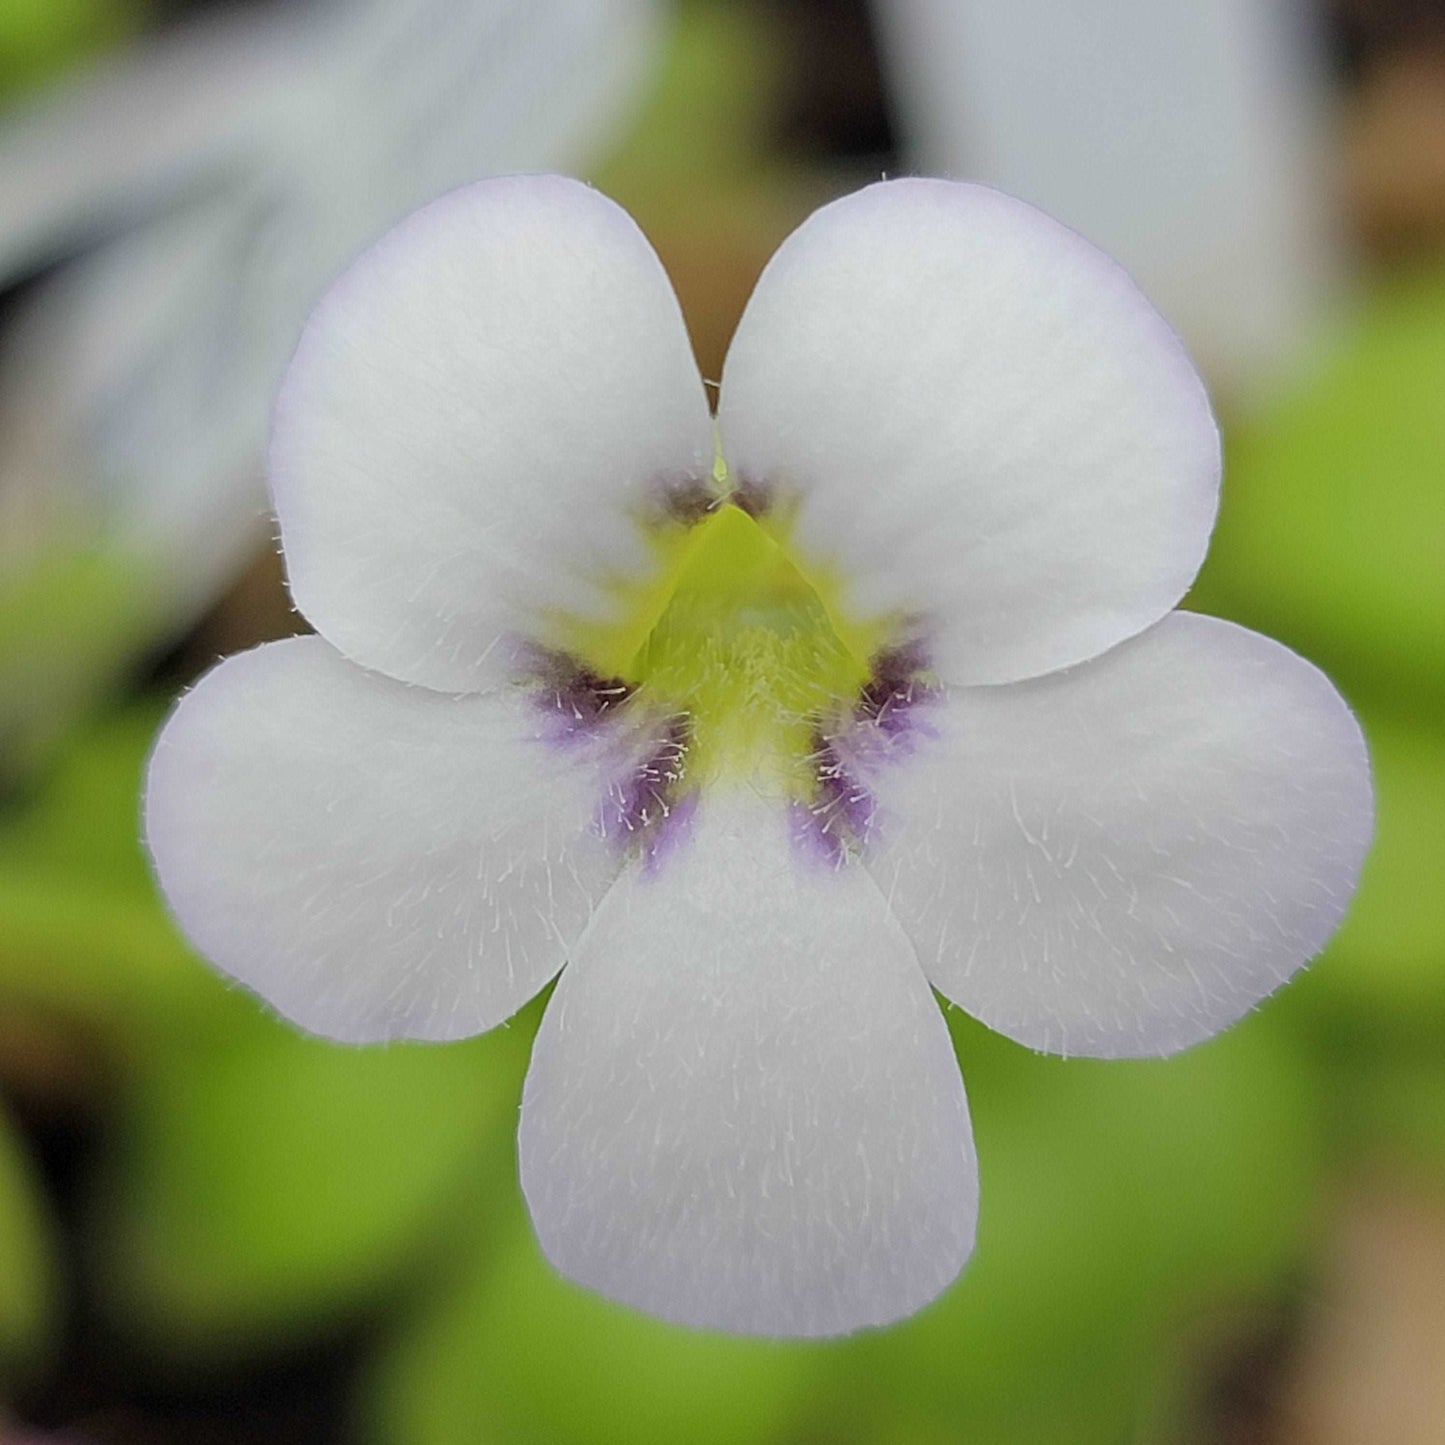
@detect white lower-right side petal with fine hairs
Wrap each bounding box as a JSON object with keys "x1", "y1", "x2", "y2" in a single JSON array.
[{"x1": 855, "y1": 613, "x2": 1373, "y2": 1056}]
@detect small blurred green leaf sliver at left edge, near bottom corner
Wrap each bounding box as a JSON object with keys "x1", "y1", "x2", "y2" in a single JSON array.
[{"x1": 0, "y1": 1110, "x2": 56, "y2": 1379}]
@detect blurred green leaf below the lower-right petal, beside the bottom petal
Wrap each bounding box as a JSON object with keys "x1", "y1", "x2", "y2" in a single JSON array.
[{"x1": 840, "y1": 1010, "x2": 1319, "y2": 1445}]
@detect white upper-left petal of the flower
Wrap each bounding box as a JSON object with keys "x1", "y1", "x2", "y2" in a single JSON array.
[{"x1": 270, "y1": 176, "x2": 712, "y2": 691}]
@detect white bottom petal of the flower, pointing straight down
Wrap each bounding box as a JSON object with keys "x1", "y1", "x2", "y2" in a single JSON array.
[{"x1": 520, "y1": 793, "x2": 977, "y2": 1335}]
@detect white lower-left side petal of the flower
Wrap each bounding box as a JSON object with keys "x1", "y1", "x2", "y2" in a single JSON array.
[{"x1": 146, "y1": 637, "x2": 661, "y2": 1042}]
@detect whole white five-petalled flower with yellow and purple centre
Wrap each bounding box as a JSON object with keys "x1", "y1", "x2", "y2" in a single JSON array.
[{"x1": 146, "y1": 178, "x2": 1371, "y2": 1335}]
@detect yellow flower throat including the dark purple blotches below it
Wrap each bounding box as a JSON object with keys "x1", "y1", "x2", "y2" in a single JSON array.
[{"x1": 548, "y1": 485, "x2": 920, "y2": 858}]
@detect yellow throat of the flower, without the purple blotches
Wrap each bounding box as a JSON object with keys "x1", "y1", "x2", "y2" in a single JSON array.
[{"x1": 560, "y1": 504, "x2": 884, "y2": 796}]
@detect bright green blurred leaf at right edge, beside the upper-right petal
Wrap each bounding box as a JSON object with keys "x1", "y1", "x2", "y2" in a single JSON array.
[{"x1": 1194, "y1": 270, "x2": 1445, "y2": 717}]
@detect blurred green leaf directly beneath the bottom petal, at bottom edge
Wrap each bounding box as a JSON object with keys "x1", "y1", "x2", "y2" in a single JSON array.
[{"x1": 366, "y1": 1179, "x2": 828, "y2": 1445}]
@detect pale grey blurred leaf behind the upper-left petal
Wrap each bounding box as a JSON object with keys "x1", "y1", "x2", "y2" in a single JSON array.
[{"x1": 0, "y1": 0, "x2": 659, "y2": 623}]
